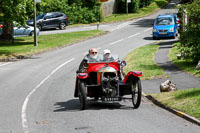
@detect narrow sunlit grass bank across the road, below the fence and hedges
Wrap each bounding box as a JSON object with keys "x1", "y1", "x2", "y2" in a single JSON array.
[{"x1": 102, "y1": 0, "x2": 168, "y2": 23}]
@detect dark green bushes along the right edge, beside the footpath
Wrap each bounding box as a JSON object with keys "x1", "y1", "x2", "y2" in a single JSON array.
[{"x1": 178, "y1": 0, "x2": 200, "y2": 62}]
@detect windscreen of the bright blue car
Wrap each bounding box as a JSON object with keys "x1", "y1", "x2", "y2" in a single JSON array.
[{"x1": 155, "y1": 17, "x2": 174, "y2": 25}]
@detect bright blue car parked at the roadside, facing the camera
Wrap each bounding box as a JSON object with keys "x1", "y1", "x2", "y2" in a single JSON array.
[{"x1": 153, "y1": 14, "x2": 179, "y2": 39}]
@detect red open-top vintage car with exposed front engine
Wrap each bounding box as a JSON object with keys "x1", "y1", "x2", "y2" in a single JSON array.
[{"x1": 74, "y1": 56, "x2": 142, "y2": 110}]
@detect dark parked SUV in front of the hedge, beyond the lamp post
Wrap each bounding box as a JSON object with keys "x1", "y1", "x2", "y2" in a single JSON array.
[{"x1": 26, "y1": 12, "x2": 69, "y2": 30}]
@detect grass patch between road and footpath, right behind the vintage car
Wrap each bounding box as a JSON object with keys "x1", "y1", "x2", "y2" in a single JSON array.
[{"x1": 124, "y1": 45, "x2": 165, "y2": 79}]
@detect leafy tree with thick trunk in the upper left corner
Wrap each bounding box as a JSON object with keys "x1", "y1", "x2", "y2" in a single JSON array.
[{"x1": 0, "y1": 0, "x2": 33, "y2": 42}]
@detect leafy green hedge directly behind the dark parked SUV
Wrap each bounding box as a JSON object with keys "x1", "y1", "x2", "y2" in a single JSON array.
[{"x1": 33, "y1": 0, "x2": 102, "y2": 24}]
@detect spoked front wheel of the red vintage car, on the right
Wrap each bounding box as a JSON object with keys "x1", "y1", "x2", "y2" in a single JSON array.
[{"x1": 132, "y1": 78, "x2": 142, "y2": 109}]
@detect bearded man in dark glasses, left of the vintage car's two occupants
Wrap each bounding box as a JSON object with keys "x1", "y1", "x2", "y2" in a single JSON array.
[{"x1": 78, "y1": 48, "x2": 100, "y2": 72}]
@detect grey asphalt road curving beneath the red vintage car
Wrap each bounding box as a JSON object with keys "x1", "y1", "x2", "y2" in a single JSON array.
[{"x1": 0, "y1": 0, "x2": 200, "y2": 133}]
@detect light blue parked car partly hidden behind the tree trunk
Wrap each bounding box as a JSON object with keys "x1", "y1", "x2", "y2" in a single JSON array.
[{"x1": 0, "y1": 24, "x2": 40, "y2": 37}]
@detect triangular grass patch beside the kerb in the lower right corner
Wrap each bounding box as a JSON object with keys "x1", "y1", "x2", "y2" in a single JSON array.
[{"x1": 152, "y1": 88, "x2": 200, "y2": 119}]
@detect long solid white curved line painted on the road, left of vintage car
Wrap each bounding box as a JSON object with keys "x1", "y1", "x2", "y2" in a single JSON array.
[{"x1": 21, "y1": 58, "x2": 75, "y2": 133}]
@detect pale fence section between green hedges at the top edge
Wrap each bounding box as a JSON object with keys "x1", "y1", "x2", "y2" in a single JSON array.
[{"x1": 101, "y1": 0, "x2": 117, "y2": 17}]
